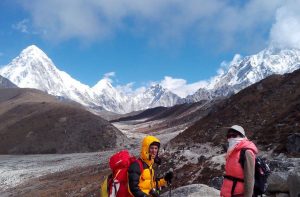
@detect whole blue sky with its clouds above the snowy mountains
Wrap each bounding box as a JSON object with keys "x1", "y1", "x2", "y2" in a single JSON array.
[{"x1": 0, "y1": 0, "x2": 300, "y2": 96}]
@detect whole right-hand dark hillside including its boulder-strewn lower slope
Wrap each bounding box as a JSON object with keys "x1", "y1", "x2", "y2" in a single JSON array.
[{"x1": 154, "y1": 70, "x2": 300, "y2": 193}]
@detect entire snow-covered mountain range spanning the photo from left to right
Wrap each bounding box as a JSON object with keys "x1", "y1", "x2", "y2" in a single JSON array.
[{"x1": 0, "y1": 45, "x2": 300, "y2": 113}]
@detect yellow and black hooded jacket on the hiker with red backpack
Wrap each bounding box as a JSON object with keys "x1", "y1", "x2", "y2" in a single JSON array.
[{"x1": 128, "y1": 136, "x2": 166, "y2": 197}]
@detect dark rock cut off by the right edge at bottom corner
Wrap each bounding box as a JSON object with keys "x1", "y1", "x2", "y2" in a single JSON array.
[{"x1": 287, "y1": 167, "x2": 300, "y2": 197}]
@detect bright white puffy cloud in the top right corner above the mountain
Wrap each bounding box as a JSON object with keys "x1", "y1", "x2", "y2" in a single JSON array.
[{"x1": 270, "y1": 0, "x2": 300, "y2": 49}]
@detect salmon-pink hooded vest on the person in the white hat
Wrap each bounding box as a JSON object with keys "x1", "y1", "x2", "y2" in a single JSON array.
[{"x1": 221, "y1": 138, "x2": 258, "y2": 197}]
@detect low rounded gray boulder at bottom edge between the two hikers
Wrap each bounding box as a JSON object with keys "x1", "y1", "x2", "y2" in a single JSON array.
[{"x1": 161, "y1": 184, "x2": 220, "y2": 197}]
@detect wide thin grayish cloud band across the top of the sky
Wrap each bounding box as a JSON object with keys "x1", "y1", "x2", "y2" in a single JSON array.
[{"x1": 21, "y1": 0, "x2": 283, "y2": 48}]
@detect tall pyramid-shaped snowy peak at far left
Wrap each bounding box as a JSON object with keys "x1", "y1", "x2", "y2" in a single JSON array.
[{"x1": 0, "y1": 45, "x2": 94, "y2": 106}]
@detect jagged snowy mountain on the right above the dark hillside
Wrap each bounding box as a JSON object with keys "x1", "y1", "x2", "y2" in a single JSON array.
[{"x1": 186, "y1": 48, "x2": 300, "y2": 102}]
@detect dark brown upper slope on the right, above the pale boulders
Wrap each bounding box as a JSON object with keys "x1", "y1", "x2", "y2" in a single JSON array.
[{"x1": 171, "y1": 70, "x2": 300, "y2": 151}]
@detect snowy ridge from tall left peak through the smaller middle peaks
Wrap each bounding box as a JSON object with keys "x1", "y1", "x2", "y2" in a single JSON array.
[{"x1": 0, "y1": 45, "x2": 179, "y2": 113}]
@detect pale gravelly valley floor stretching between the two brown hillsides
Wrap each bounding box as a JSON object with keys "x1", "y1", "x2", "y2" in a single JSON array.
[{"x1": 0, "y1": 121, "x2": 182, "y2": 196}]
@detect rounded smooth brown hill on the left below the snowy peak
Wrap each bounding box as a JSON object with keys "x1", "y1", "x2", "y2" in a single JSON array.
[{"x1": 0, "y1": 88, "x2": 127, "y2": 154}]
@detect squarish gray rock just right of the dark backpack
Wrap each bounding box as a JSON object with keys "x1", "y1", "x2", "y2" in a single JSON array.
[{"x1": 267, "y1": 172, "x2": 289, "y2": 193}]
